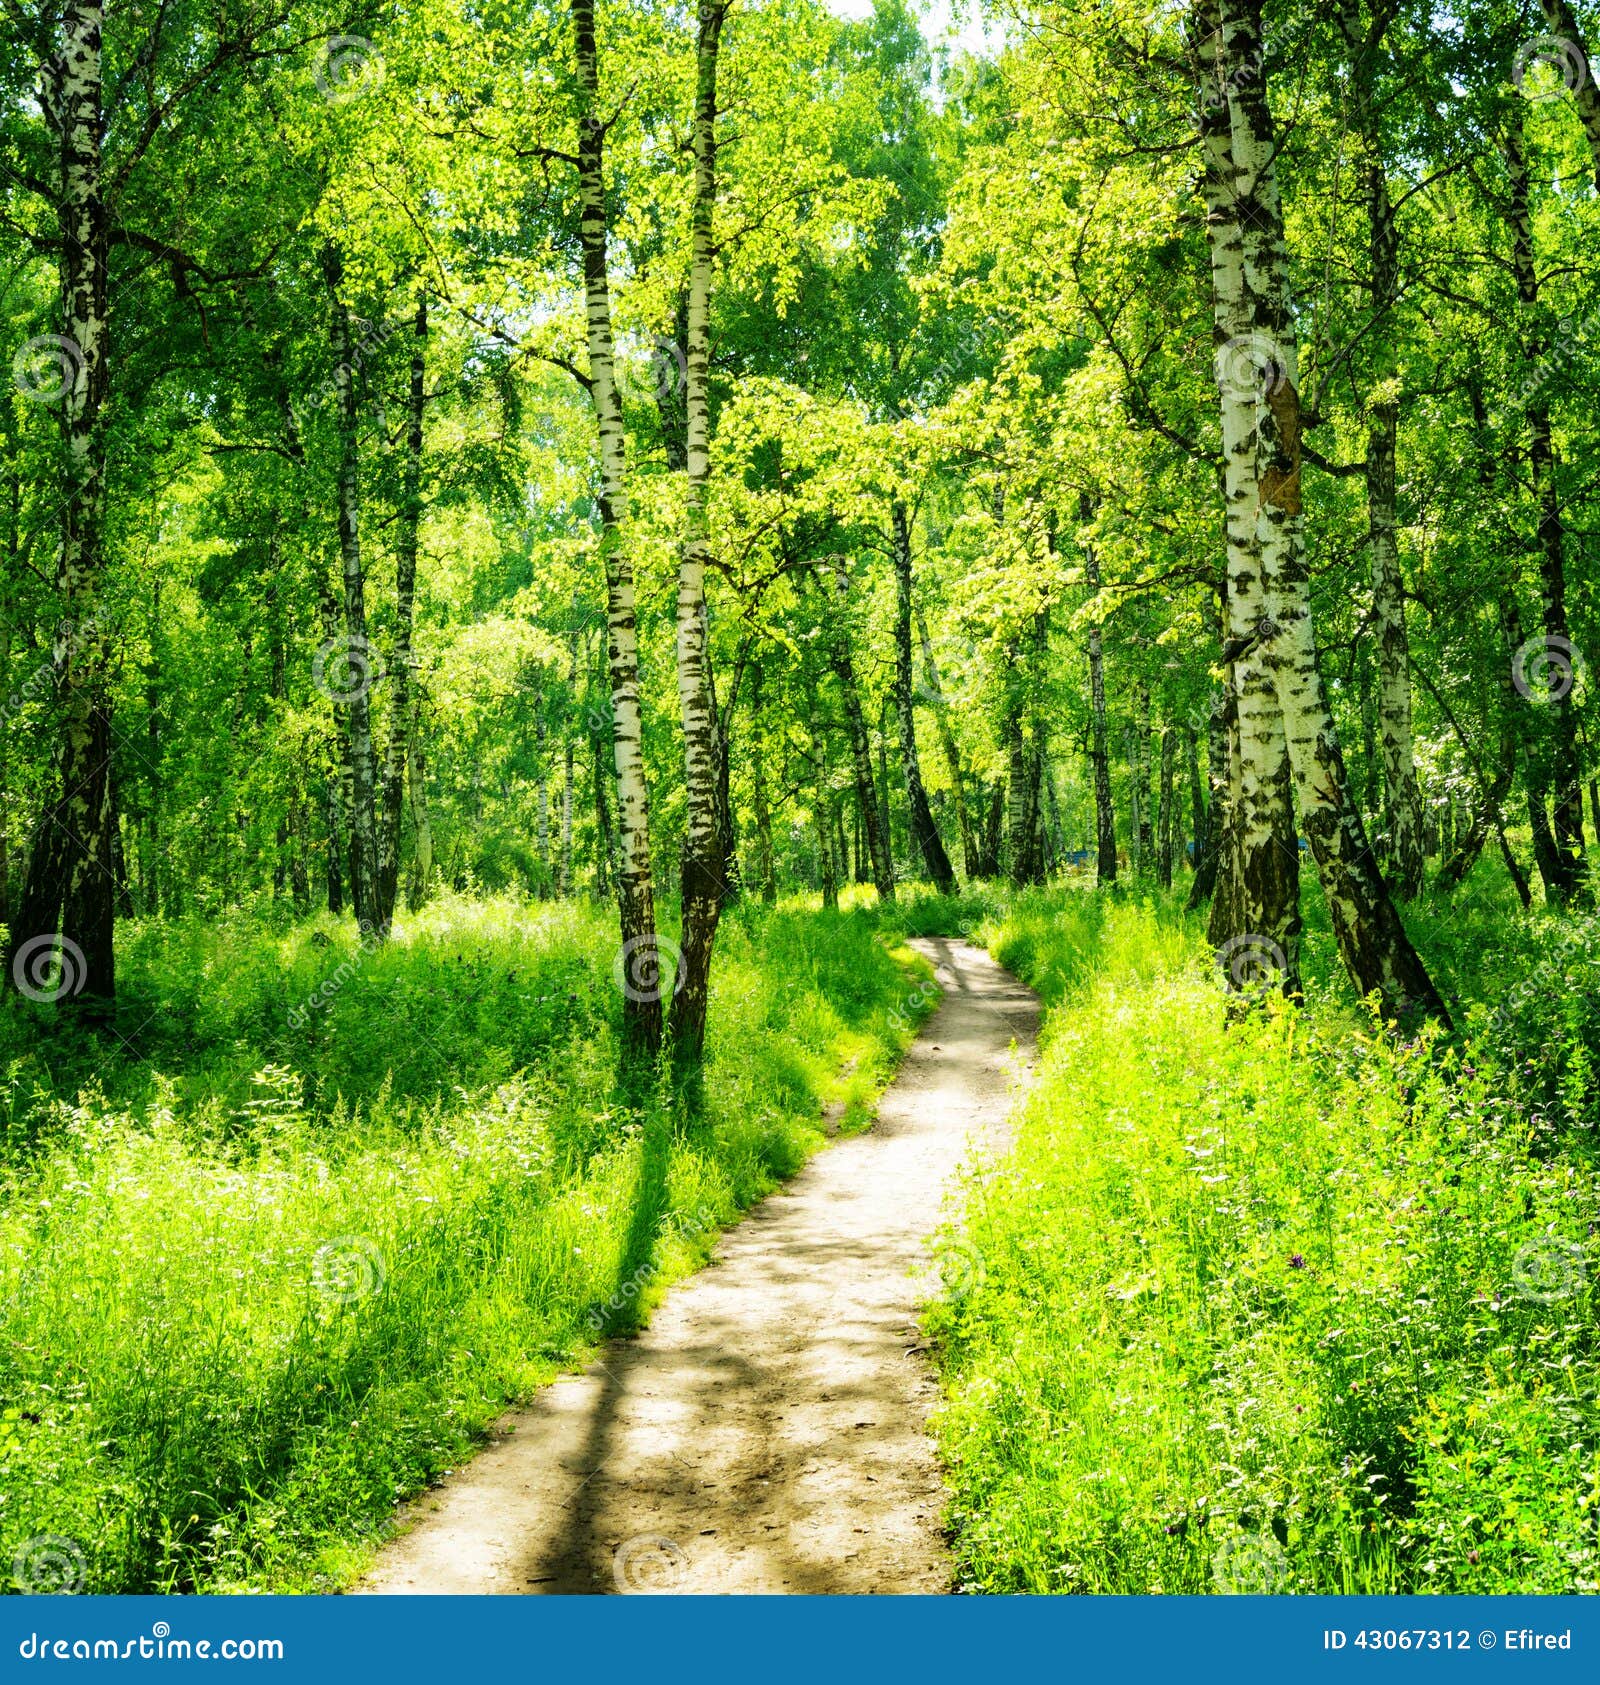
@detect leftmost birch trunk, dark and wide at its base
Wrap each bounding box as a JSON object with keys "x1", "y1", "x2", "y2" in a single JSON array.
[{"x1": 5, "y1": 0, "x2": 116, "y2": 1018}]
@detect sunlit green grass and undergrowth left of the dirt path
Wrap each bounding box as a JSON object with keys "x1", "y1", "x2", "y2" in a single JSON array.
[{"x1": 0, "y1": 900, "x2": 926, "y2": 1592}]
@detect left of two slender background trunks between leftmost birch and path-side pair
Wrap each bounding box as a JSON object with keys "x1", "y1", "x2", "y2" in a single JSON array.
[{"x1": 322, "y1": 241, "x2": 382, "y2": 932}]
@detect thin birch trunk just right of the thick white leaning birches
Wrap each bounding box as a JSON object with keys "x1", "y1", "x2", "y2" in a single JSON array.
[{"x1": 1341, "y1": 0, "x2": 1423, "y2": 900}]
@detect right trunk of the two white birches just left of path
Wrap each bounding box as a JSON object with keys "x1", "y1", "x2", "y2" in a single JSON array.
[{"x1": 672, "y1": 0, "x2": 728, "y2": 1062}]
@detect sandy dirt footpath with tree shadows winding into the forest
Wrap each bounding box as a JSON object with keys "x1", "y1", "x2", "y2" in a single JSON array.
[{"x1": 359, "y1": 940, "x2": 1037, "y2": 1592}]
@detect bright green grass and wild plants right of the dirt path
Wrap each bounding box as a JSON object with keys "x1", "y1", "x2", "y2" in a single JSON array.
[{"x1": 931, "y1": 890, "x2": 1600, "y2": 1594}]
